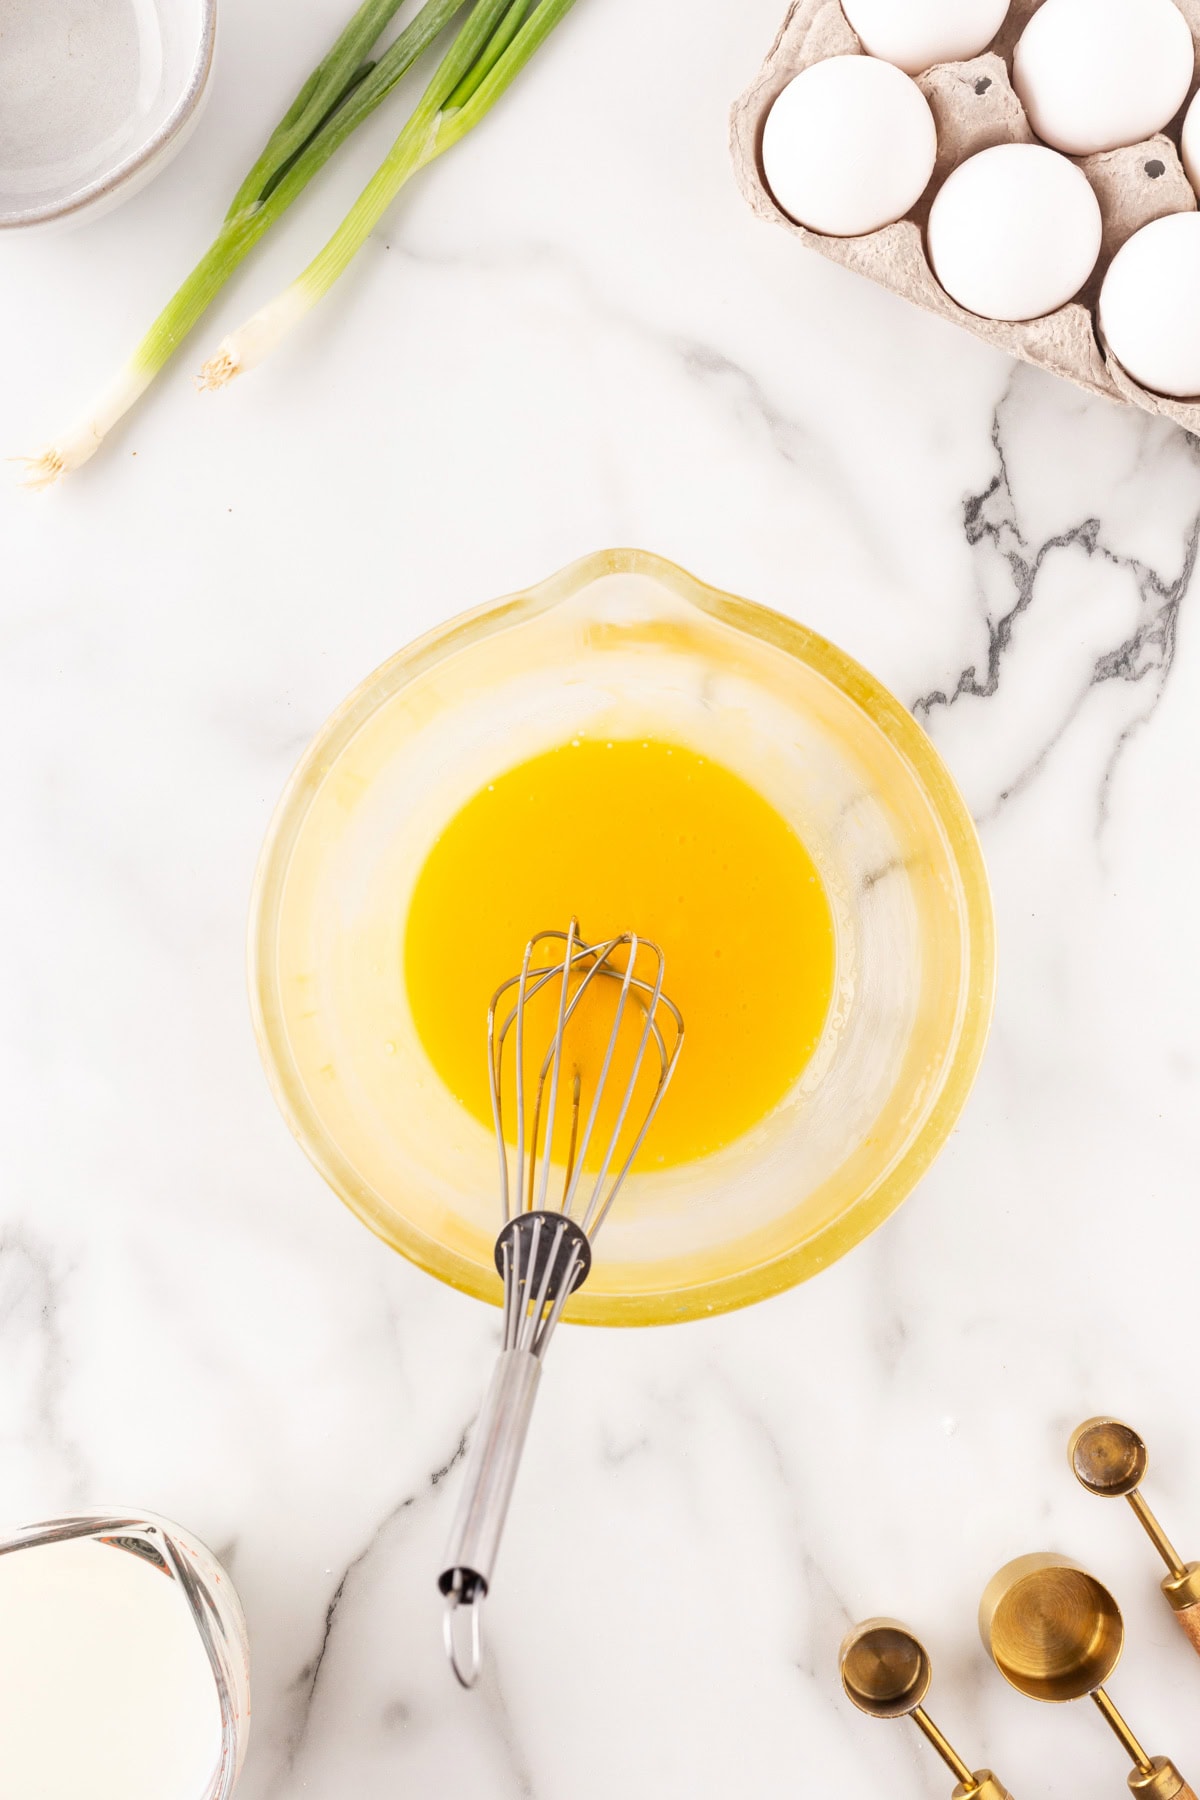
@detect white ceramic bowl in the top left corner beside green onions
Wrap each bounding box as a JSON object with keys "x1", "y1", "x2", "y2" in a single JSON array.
[{"x1": 0, "y1": 0, "x2": 216, "y2": 230}]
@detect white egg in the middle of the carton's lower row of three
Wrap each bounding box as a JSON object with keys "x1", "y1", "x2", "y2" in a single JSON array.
[{"x1": 928, "y1": 144, "x2": 1101, "y2": 320}]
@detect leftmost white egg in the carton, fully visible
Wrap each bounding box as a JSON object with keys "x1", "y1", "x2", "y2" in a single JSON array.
[{"x1": 763, "y1": 56, "x2": 937, "y2": 238}]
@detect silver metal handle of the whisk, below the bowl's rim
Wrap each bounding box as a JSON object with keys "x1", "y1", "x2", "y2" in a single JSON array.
[{"x1": 437, "y1": 1350, "x2": 542, "y2": 1656}]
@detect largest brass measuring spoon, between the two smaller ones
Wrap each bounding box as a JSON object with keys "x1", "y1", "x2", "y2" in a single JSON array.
[{"x1": 979, "y1": 1555, "x2": 1196, "y2": 1800}]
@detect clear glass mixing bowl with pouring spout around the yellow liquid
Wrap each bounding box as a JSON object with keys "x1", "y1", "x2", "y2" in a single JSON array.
[{"x1": 250, "y1": 551, "x2": 995, "y2": 1325}]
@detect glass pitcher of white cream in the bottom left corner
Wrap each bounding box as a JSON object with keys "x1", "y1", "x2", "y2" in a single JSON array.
[{"x1": 0, "y1": 1512, "x2": 250, "y2": 1800}]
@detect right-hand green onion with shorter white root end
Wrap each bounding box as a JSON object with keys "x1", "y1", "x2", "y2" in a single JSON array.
[{"x1": 200, "y1": 0, "x2": 574, "y2": 387}]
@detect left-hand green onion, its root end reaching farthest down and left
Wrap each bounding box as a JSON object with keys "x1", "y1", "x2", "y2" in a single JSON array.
[{"x1": 27, "y1": 0, "x2": 464, "y2": 488}]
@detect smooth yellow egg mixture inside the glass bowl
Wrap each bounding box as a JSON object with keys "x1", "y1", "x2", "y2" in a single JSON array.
[{"x1": 403, "y1": 738, "x2": 835, "y2": 1168}]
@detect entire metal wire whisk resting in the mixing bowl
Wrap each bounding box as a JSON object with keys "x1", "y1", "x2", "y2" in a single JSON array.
[{"x1": 437, "y1": 920, "x2": 684, "y2": 1687}]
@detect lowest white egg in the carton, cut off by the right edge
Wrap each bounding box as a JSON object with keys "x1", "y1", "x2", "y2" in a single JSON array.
[{"x1": 1099, "y1": 212, "x2": 1200, "y2": 400}]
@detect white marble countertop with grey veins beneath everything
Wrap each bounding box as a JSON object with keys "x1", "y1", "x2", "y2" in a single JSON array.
[{"x1": 0, "y1": 0, "x2": 1200, "y2": 1800}]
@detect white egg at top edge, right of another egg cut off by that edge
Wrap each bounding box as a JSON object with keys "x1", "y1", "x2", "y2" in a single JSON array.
[{"x1": 1013, "y1": 0, "x2": 1196, "y2": 157}]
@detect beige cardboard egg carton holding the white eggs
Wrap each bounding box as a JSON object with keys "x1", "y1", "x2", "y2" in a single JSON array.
[{"x1": 730, "y1": 0, "x2": 1200, "y2": 432}]
